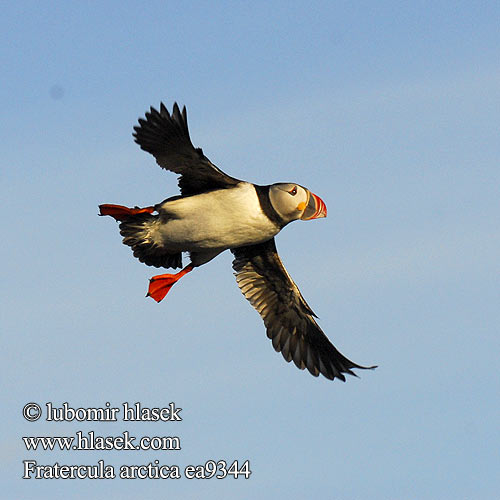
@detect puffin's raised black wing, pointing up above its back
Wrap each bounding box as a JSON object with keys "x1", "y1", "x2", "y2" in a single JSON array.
[{"x1": 133, "y1": 103, "x2": 240, "y2": 195}]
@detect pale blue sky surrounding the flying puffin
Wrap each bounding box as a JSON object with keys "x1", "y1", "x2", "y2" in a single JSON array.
[{"x1": 0, "y1": 1, "x2": 500, "y2": 500}]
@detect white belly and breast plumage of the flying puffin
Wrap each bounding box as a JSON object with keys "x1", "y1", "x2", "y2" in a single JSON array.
[{"x1": 148, "y1": 183, "x2": 279, "y2": 256}]
